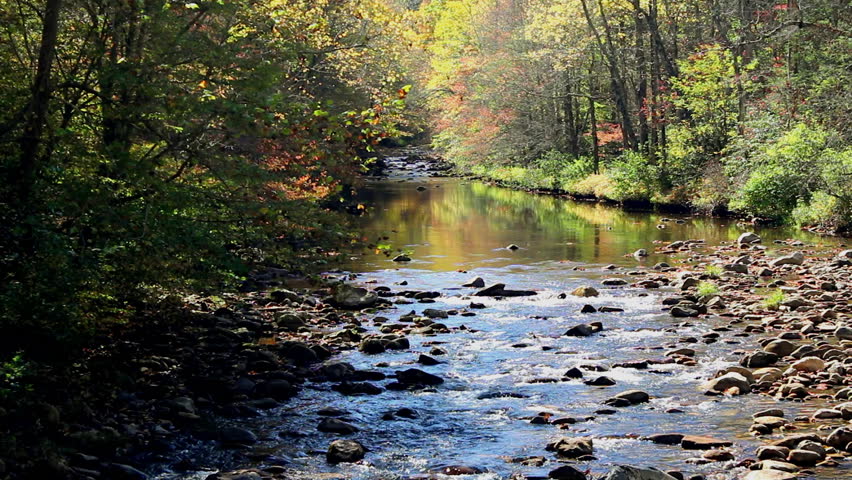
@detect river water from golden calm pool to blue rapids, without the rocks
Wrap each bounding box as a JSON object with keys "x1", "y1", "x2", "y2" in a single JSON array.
[{"x1": 163, "y1": 158, "x2": 850, "y2": 480}]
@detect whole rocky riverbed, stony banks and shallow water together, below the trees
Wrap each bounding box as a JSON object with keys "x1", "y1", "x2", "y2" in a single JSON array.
[{"x1": 2, "y1": 153, "x2": 852, "y2": 480}]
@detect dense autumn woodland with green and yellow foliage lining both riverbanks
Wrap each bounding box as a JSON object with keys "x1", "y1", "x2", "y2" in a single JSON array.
[{"x1": 0, "y1": 0, "x2": 852, "y2": 386}]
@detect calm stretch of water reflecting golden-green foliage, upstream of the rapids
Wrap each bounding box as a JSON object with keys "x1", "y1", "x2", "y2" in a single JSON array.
[{"x1": 352, "y1": 179, "x2": 826, "y2": 271}]
